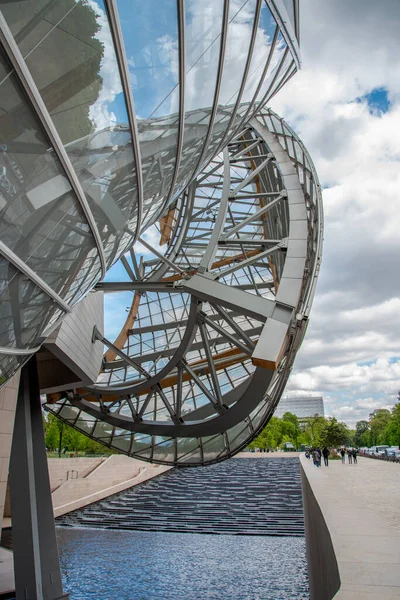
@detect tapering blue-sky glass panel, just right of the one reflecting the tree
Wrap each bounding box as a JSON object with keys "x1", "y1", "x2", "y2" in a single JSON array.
[{"x1": 117, "y1": 0, "x2": 179, "y2": 229}]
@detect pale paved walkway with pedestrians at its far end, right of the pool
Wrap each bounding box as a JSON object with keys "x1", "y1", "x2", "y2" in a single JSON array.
[{"x1": 300, "y1": 455, "x2": 400, "y2": 600}]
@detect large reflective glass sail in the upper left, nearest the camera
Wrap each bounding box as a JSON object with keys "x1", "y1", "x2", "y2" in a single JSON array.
[{"x1": 0, "y1": 0, "x2": 298, "y2": 378}]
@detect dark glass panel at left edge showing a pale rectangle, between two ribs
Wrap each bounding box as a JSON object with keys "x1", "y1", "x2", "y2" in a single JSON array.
[{"x1": 0, "y1": 45, "x2": 100, "y2": 303}]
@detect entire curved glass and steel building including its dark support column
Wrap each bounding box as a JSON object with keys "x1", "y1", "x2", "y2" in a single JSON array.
[{"x1": 0, "y1": 0, "x2": 323, "y2": 600}]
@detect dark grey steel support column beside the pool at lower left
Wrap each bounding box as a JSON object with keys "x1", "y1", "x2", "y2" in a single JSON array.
[{"x1": 9, "y1": 356, "x2": 69, "y2": 600}]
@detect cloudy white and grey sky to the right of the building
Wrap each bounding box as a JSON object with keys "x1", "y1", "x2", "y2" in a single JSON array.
[{"x1": 272, "y1": 0, "x2": 400, "y2": 424}]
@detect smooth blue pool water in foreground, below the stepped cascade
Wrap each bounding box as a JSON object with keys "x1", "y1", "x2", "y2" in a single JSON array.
[{"x1": 57, "y1": 527, "x2": 309, "y2": 600}]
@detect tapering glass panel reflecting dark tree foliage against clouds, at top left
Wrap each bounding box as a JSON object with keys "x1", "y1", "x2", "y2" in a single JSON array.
[{"x1": 2, "y1": 0, "x2": 138, "y2": 266}]
